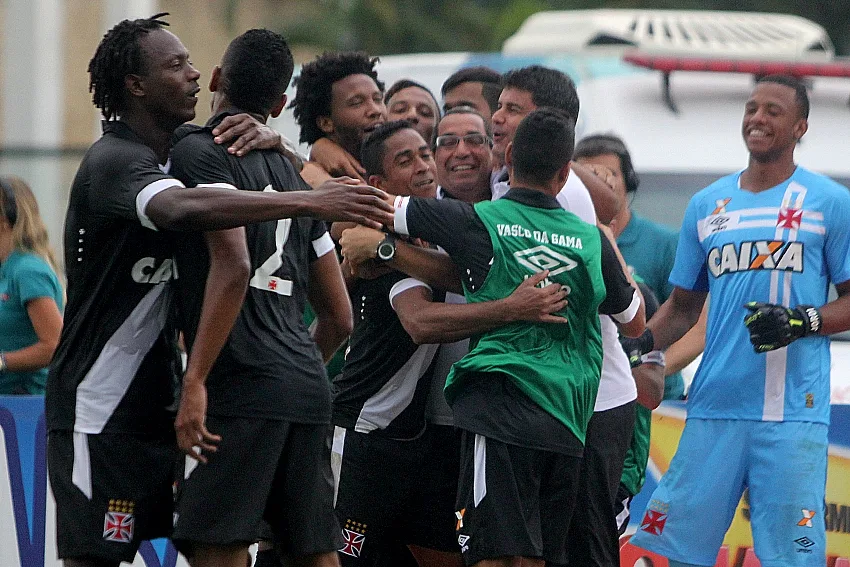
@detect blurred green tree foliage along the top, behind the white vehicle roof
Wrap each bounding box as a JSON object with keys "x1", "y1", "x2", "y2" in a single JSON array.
[{"x1": 268, "y1": 0, "x2": 850, "y2": 54}]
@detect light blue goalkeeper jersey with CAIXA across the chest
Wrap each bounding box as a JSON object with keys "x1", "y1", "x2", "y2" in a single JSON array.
[{"x1": 670, "y1": 167, "x2": 850, "y2": 423}]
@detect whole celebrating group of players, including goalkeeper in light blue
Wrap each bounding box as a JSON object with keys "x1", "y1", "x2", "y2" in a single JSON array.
[{"x1": 46, "y1": 10, "x2": 850, "y2": 567}]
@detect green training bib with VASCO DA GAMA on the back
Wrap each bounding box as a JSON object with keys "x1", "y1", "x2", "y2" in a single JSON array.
[{"x1": 446, "y1": 199, "x2": 605, "y2": 443}]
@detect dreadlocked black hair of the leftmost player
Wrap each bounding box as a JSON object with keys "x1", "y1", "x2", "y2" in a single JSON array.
[{"x1": 88, "y1": 12, "x2": 168, "y2": 120}]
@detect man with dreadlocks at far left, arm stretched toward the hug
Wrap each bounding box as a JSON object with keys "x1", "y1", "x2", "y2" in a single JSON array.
[{"x1": 46, "y1": 14, "x2": 392, "y2": 567}]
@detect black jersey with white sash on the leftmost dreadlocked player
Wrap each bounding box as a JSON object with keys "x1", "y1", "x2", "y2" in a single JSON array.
[{"x1": 45, "y1": 121, "x2": 179, "y2": 435}]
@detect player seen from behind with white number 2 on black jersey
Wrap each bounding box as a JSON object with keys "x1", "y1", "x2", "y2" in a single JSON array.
[{"x1": 172, "y1": 30, "x2": 352, "y2": 567}]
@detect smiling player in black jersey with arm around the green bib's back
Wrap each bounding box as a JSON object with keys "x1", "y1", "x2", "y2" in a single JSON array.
[{"x1": 334, "y1": 120, "x2": 564, "y2": 567}]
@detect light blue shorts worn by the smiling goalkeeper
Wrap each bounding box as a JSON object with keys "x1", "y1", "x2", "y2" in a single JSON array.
[{"x1": 631, "y1": 419, "x2": 828, "y2": 567}]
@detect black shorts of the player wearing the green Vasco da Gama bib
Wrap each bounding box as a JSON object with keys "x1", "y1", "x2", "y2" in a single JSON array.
[{"x1": 456, "y1": 431, "x2": 581, "y2": 565}]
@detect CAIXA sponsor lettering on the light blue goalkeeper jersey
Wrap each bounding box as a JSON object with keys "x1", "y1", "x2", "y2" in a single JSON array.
[{"x1": 708, "y1": 240, "x2": 803, "y2": 278}]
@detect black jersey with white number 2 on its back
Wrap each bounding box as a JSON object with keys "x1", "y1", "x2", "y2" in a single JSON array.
[{"x1": 172, "y1": 110, "x2": 334, "y2": 423}]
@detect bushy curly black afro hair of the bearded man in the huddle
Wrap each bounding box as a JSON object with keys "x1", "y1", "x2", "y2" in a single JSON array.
[{"x1": 289, "y1": 51, "x2": 384, "y2": 144}]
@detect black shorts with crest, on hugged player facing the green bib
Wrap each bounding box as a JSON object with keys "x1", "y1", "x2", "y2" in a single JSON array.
[{"x1": 334, "y1": 427, "x2": 457, "y2": 567}]
